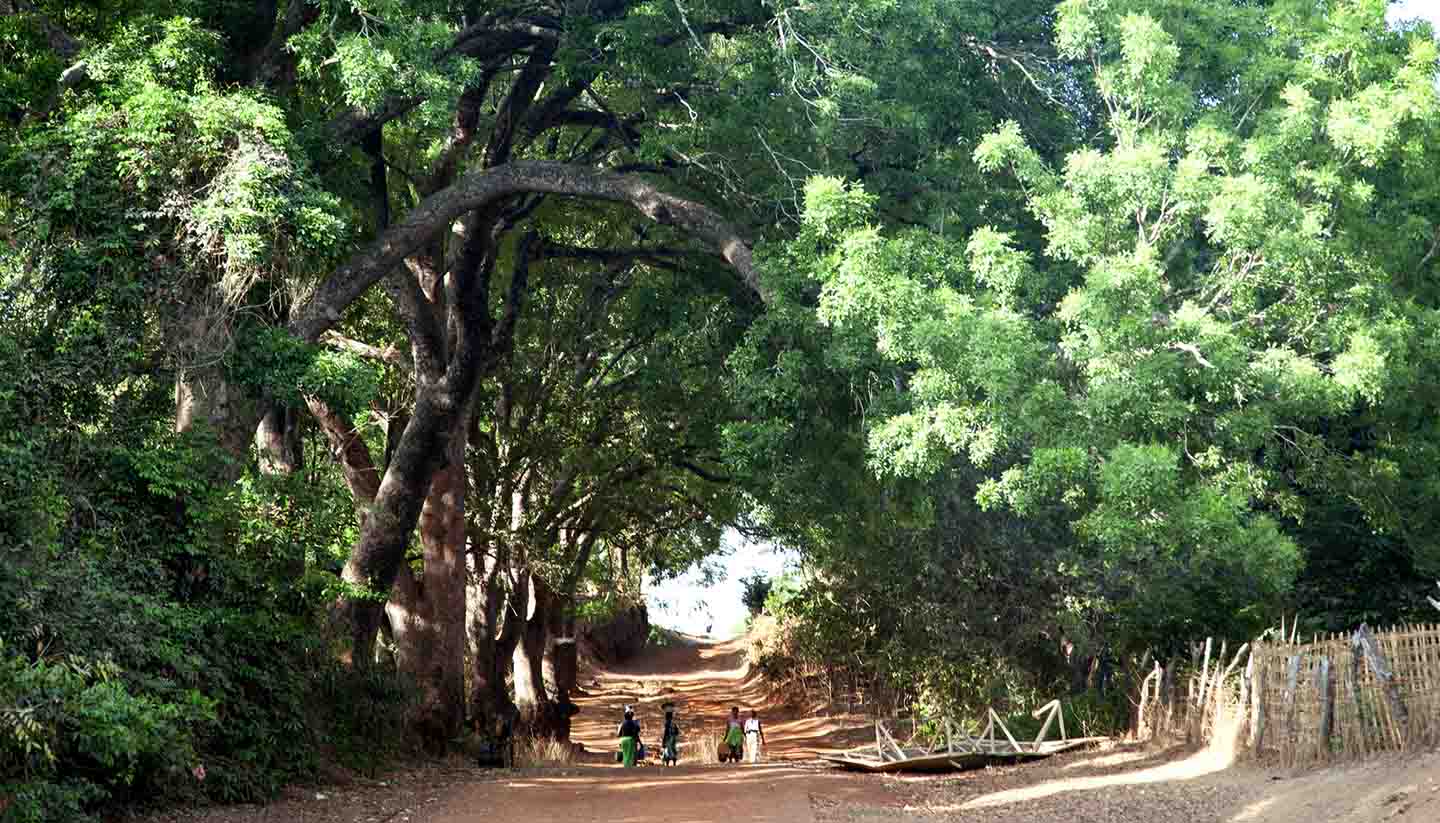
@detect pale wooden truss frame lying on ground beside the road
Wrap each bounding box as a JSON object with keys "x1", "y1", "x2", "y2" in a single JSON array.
[{"x1": 821, "y1": 701, "x2": 1107, "y2": 773}]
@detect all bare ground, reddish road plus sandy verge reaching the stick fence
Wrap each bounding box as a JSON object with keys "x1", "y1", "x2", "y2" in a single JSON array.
[{"x1": 137, "y1": 639, "x2": 1440, "y2": 823}]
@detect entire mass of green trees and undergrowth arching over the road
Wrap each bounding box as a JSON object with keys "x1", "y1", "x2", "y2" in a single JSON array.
[{"x1": 0, "y1": 0, "x2": 1440, "y2": 820}]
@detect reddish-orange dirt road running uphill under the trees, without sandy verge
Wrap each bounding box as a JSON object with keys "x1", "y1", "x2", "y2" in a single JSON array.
[{"x1": 423, "y1": 637, "x2": 899, "y2": 823}]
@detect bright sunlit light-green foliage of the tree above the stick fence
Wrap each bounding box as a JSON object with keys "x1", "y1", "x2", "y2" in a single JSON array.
[{"x1": 771, "y1": 0, "x2": 1440, "y2": 661}]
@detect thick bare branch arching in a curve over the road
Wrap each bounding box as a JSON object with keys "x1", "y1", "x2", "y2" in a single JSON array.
[{"x1": 291, "y1": 161, "x2": 769, "y2": 341}]
